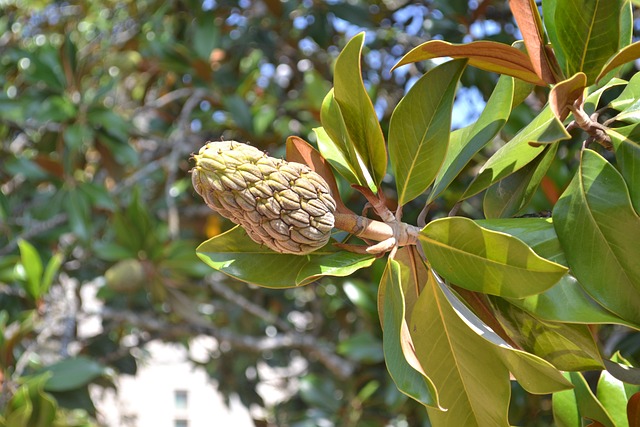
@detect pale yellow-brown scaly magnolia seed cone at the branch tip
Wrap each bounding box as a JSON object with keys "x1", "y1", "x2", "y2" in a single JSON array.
[{"x1": 192, "y1": 141, "x2": 336, "y2": 255}]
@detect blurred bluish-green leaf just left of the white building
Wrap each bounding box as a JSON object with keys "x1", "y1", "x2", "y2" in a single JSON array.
[{"x1": 44, "y1": 356, "x2": 105, "y2": 392}]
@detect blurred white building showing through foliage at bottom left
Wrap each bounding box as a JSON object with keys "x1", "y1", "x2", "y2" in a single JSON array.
[{"x1": 98, "y1": 343, "x2": 254, "y2": 427}]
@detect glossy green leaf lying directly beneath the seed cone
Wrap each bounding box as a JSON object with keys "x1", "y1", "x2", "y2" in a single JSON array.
[{"x1": 196, "y1": 226, "x2": 375, "y2": 288}]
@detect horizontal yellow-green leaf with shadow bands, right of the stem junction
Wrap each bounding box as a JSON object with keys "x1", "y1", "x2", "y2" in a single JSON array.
[{"x1": 418, "y1": 217, "x2": 567, "y2": 298}]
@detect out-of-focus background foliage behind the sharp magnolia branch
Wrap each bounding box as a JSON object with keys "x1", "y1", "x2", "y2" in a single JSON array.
[{"x1": 0, "y1": 0, "x2": 640, "y2": 426}]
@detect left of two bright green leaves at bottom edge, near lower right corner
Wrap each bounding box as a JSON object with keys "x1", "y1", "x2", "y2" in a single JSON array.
[{"x1": 552, "y1": 372, "x2": 615, "y2": 427}]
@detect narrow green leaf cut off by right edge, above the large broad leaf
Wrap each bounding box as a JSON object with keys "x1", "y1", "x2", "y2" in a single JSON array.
[{"x1": 607, "y1": 125, "x2": 640, "y2": 213}]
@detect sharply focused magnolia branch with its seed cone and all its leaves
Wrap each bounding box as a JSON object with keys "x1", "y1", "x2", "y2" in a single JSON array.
[{"x1": 193, "y1": 0, "x2": 640, "y2": 426}]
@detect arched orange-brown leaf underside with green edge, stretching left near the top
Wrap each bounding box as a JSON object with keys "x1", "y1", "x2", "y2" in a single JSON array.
[{"x1": 392, "y1": 40, "x2": 546, "y2": 86}]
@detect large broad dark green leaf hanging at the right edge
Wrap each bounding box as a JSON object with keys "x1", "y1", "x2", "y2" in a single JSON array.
[{"x1": 553, "y1": 150, "x2": 640, "y2": 324}]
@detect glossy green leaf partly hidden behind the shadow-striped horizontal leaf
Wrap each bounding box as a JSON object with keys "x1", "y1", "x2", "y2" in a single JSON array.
[{"x1": 477, "y1": 218, "x2": 640, "y2": 329}]
